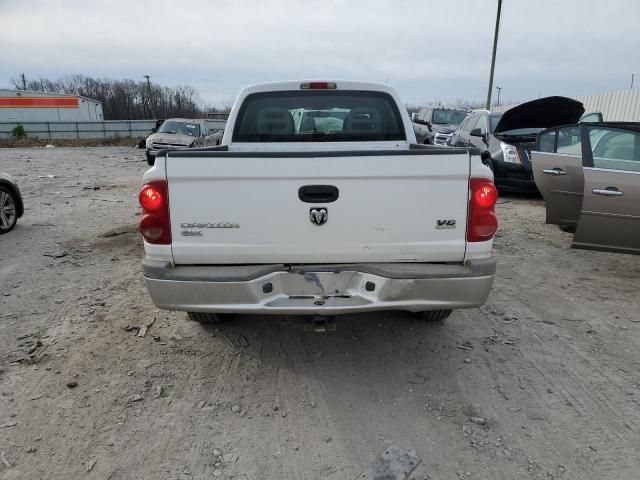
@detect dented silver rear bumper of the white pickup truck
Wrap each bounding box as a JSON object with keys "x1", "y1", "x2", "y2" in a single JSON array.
[{"x1": 143, "y1": 258, "x2": 496, "y2": 315}]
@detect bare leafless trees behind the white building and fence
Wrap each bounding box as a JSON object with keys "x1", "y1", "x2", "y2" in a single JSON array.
[{"x1": 12, "y1": 75, "x2": 204, "y2": 120}]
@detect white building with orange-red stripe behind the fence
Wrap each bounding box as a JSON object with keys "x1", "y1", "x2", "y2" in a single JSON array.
[{"x1": 0, "y1": 89, "x2": 104, "y2": 123}]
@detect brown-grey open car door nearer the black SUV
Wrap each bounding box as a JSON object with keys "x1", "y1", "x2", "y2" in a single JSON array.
[{"x1": 531, "y1": 125, "x2": 584, "y2": 228}]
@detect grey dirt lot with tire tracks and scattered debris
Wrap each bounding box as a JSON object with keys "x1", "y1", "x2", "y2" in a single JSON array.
[{"x1": 0, "y1": 147, "x2": 640, "y2": 480}]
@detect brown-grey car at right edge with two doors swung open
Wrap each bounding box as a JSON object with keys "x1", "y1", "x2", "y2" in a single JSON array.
[{"x1": 531, "y1": 122, "x2": 640, "y2": 254}]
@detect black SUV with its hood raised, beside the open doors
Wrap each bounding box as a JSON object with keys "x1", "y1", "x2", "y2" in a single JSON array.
[{"x1": 451, "y1": 97, "x2": 584, "y2": 193}]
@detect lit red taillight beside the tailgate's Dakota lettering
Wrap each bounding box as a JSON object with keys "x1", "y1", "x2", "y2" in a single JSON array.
[{"x1": 138, "y1": 180, "x2": 171, "y2": 245}]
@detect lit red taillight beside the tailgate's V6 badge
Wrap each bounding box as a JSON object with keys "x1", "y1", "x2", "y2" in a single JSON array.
[{"x1": 467, "y1": 178, "x2": 498, "y2": 242}]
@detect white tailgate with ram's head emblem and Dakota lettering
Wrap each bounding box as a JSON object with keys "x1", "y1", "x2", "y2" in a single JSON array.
[{"x1": 166, "y1": 150, "x2": 470, "y2": 265}]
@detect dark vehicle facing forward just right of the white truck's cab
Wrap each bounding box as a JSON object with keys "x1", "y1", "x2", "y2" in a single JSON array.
[{"x1": 413, "y1": 107, "x2": 469, "y2": 145}]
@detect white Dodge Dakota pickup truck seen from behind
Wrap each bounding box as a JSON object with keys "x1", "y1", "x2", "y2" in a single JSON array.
[{"x1": 139, "y1": 81, "x2": 497, "y2": 322}]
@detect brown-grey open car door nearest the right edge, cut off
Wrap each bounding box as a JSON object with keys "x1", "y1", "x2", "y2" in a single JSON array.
[{"x1": 571, "y1": 124, "x2": 640, "y2": 254}]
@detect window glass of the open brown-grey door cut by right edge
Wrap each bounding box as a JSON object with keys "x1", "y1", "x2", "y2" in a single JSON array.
[{"x1": 589, "y1": 127, "x2": 640, "y2": 172}]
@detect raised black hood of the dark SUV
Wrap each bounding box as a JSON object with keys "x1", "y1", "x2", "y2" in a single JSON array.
[{"x1": 494, "y1": 97, "x2": 584, "y2": 135}]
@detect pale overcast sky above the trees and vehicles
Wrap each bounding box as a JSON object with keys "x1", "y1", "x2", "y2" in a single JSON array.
[{"x1": 0, "y1": 0, "x2": 640, "y2": 105}]
